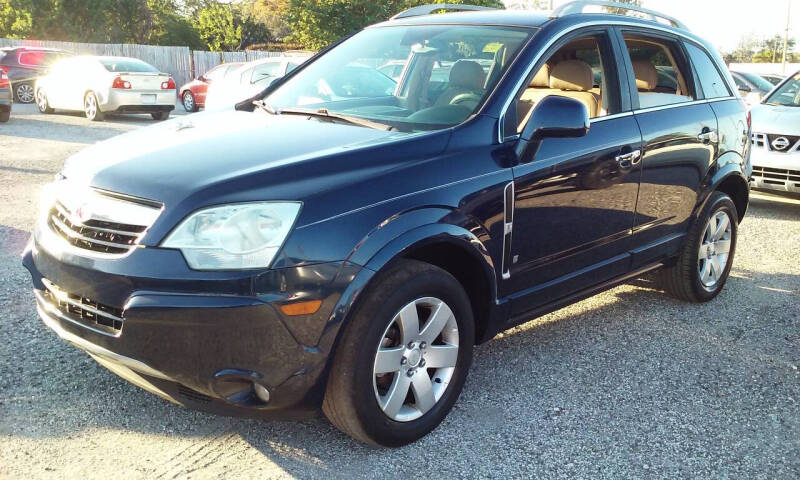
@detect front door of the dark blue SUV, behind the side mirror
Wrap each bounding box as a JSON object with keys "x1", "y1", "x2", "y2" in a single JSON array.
[{"x1": 503, "y1": 28, "x2": 641, "y2": 315}]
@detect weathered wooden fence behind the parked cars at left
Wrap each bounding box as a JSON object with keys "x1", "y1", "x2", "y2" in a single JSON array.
[{"x1": 0, "y1": 38, "x2": 310, "y2": 86}]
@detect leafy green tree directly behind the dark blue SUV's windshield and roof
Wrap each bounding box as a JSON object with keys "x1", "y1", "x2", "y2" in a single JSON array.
[{"x1": 287, "y1": 0, "x2": 503, "y2": 49}]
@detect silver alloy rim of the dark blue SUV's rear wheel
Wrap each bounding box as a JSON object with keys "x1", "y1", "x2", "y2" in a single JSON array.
[{"x1": 697, "y1": 211, "x2": 733, "y2": 290}]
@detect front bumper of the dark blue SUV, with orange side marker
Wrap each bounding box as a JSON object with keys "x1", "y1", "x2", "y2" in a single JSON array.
[{"x1": 23, "y1": 234, "x2": 360, "y2": 418}]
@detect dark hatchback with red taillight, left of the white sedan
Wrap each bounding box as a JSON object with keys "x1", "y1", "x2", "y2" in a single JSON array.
[{"x1": 0, "y1": 47, "x2": 72, "y2": 103}]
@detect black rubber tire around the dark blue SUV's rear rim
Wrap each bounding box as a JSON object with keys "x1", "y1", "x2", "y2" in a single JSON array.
[{"x1": 658, "y1": 192, "x2": 739, "y2": 302}]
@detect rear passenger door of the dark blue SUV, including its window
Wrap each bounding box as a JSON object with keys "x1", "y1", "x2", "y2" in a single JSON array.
[{"x1": 617, "y1": 28, "x2": 719, "y2": 268}]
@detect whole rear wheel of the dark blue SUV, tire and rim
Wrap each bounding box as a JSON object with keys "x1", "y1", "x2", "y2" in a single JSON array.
[{"x1": 660, "y1": 192, "x2": 739, "y2": 302}]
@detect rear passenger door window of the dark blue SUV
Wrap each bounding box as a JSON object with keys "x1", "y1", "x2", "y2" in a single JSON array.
[{"x1": 624, "y1": 34, "x2": 697, "y2": 108}]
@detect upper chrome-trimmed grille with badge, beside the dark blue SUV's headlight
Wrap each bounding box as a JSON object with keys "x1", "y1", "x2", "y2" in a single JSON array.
[{"x1": 48, "y1": 201, "x2": 147, "y2": 255}]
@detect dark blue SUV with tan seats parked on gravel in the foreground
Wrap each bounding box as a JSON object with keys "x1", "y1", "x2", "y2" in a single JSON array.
[{"x1": 23, "y1": 2, "x2": 751, "y2": 446}]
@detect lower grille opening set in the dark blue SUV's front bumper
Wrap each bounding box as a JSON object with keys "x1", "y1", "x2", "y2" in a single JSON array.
[{"x1": 42, "y1": 279, "x2": 124, "y2": 335}]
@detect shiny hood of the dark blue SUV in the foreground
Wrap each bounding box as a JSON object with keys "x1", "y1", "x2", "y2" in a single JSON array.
[{"x1": 62, "y1": 111, "x2": 409, "y2": 207}]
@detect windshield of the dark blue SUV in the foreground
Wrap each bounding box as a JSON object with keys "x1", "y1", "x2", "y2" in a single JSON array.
[{"x1": 265, "y1": 25, "x2": 536, "y2": 131}]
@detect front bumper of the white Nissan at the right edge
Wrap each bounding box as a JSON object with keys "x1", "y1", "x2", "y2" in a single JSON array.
[{"x1": 750, "y1": 147, "x2": 800, "y2": 193}]
